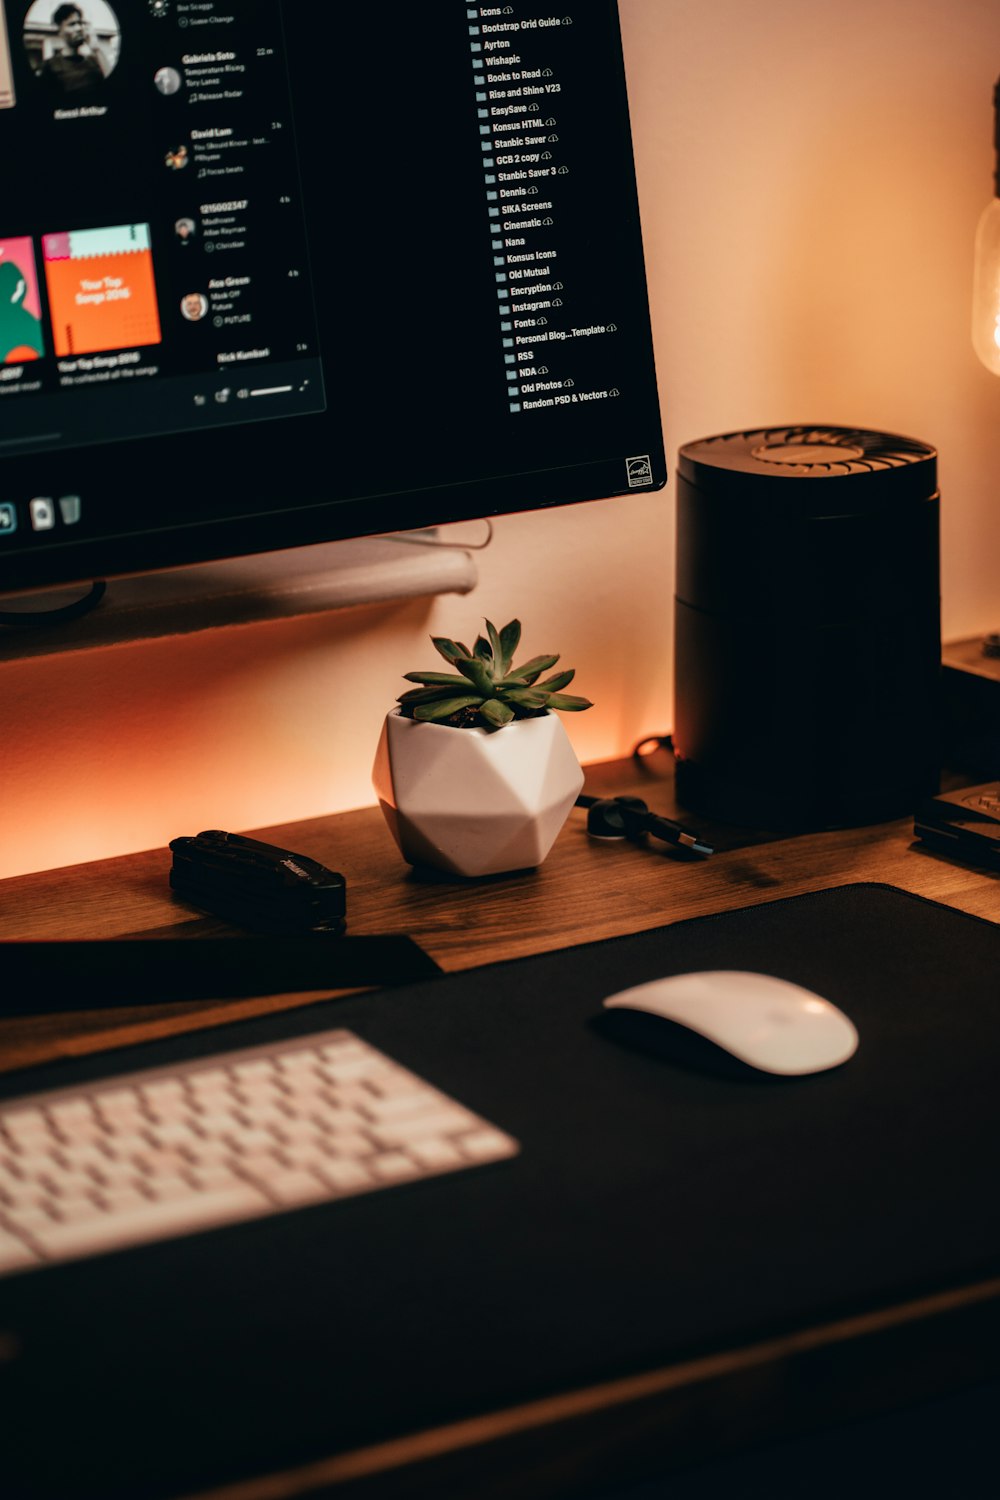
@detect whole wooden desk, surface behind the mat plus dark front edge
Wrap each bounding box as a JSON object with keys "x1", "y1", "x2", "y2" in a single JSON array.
[{"x1": 0, "y1": 753, "x2": 1000, "y2": 1500}]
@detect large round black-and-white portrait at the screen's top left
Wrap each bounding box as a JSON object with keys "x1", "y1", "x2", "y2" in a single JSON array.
[{"x1": 22, "y1": 0, "x2": 121, "y2": 99}]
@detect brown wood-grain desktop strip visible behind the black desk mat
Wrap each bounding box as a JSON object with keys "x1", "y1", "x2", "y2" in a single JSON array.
[{"x1": 0, "y1": 752, "x2": 1000, "y2": 1070}]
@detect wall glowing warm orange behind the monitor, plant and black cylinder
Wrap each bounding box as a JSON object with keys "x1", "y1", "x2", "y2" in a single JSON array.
[{"x1": 0, "y1": 0, "x2": 1000, "y2": 875}]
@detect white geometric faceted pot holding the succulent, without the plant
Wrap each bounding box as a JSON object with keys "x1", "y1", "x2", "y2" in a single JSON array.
[{"x1": 372, "y1": 710, "x2": 583, "y2": 876}]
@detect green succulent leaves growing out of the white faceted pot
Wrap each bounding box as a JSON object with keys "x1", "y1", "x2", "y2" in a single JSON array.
[{"x1": 397, "y1": 620, "x2": 592, "y2": 729}]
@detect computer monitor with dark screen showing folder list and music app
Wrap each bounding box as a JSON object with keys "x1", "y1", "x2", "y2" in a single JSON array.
[{"x1": 0, "y1": 0, "x2": 666, "y2": 593}]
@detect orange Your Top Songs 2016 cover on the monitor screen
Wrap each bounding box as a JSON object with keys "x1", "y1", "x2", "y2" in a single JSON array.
[{"x1": 42, "y1": 224, "x2": 160, "y2": 357}]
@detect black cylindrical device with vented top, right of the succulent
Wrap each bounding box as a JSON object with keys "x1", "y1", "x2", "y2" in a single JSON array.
[{"x1": 673, "y1": 426, "x2": 942, "y2": 831}]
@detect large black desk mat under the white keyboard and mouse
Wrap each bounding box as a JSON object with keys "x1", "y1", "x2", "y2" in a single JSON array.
[{"x1": 0, "y1": 885, "x2": 1000, "y2": 1500}]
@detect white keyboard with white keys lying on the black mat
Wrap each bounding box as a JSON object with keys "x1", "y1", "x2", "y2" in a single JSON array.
[{"x1": 0, "y1": 1031, "x2": 519, "y2": 1275}]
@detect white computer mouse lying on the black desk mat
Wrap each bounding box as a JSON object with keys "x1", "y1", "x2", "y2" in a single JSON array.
[{"x1": 604, "y1": 969, "x2": 858, "y2": 1076}]
